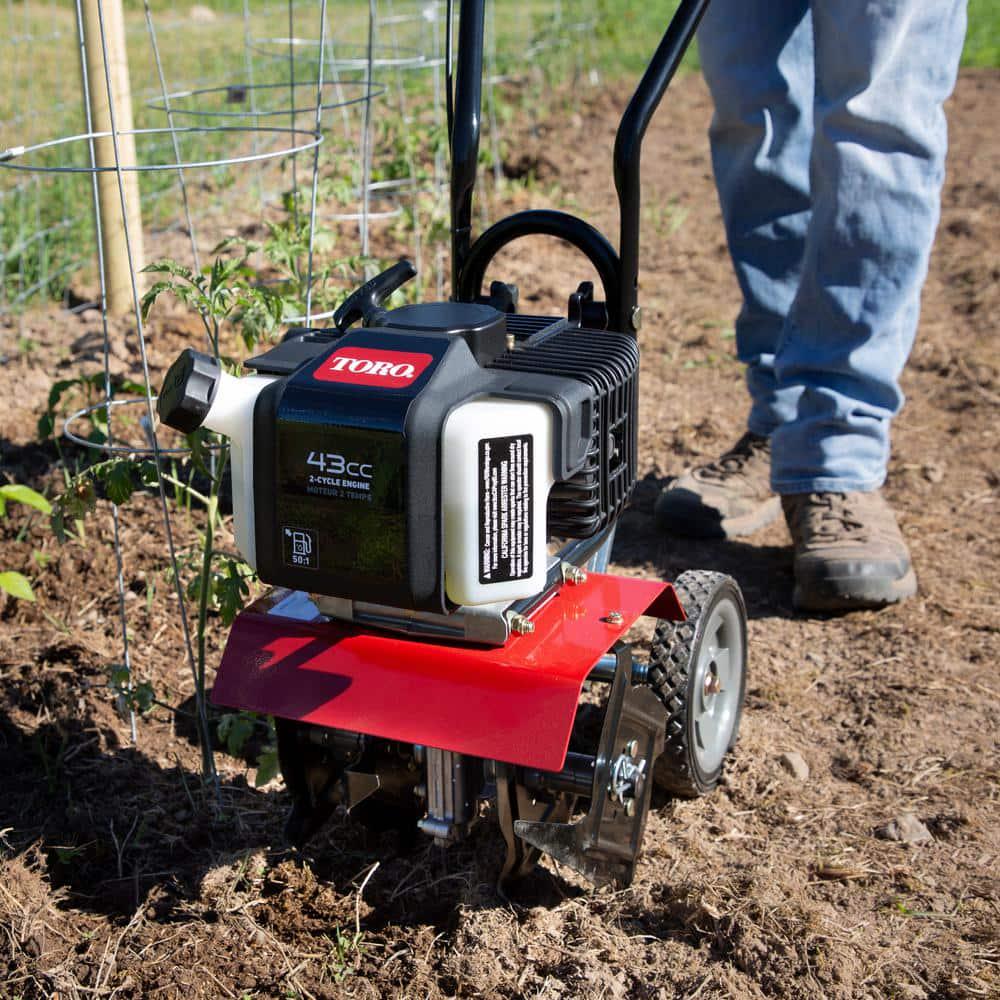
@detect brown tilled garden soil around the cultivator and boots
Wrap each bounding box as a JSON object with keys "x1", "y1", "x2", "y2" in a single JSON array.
[{"x1": 0, "y1": 72, "x2": 1000, "y2": 1000}]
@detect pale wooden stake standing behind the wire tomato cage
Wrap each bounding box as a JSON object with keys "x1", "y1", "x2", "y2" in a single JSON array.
[{"x1": 81, "y1": 0, "x2": 144, "y2": 316}]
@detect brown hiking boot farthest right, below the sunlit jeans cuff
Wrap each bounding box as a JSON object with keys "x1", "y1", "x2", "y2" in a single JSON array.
[{"x1": 781, "y1": 492, "x2": 917, "y2": 611}]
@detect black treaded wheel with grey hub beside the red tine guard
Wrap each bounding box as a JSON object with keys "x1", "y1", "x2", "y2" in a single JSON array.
[{"x1": 647, "y1": 570, "x2": 747, "y2": 798}]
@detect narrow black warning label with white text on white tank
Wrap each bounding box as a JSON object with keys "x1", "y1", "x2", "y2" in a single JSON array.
[{"x1": 479, "y1": 434, "x2": 533, "y2": 583}]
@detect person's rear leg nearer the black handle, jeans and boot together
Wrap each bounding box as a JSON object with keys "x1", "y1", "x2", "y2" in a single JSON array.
[{"x1": 656, "y1": 0, "x2": 813, "y2": 537}]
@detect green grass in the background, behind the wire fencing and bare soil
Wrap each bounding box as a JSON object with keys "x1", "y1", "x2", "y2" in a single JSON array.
[{"x1": 0, "y1": 0, "x2": 1000, "y2": 309}]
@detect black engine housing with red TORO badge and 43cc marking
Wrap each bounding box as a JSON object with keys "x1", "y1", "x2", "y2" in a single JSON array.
[{"x1": 247, "y1": 303, "x2": 638, "y2": 612}]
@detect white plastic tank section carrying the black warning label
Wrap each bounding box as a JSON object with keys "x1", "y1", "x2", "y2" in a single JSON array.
[{"x1": 441, "y1": 398, "x2": 553, "y2": 604}]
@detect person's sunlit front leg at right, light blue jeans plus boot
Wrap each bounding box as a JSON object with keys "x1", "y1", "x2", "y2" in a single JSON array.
[{"x1": 771, "y1": 0, "x2": 965, "y2": 610}]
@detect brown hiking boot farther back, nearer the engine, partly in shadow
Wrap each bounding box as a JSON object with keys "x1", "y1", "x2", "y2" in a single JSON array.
[{"x1": 654, "y1": 431, "x2": 781, "y2": 538}]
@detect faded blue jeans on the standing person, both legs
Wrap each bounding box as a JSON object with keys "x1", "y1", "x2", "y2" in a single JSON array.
[{"x1": 699, "y1": 0, "x2": 966, "y2": 493}]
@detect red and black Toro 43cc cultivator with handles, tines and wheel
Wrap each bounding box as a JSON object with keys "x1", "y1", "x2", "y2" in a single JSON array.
[{"x1": 158, "y1": 0, "x2": 746, "y2": 885}]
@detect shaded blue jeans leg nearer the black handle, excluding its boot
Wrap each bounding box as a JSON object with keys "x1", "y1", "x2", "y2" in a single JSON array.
[{"x1": 698, "y1": 0, "x2": 814, "y2": 437}]
